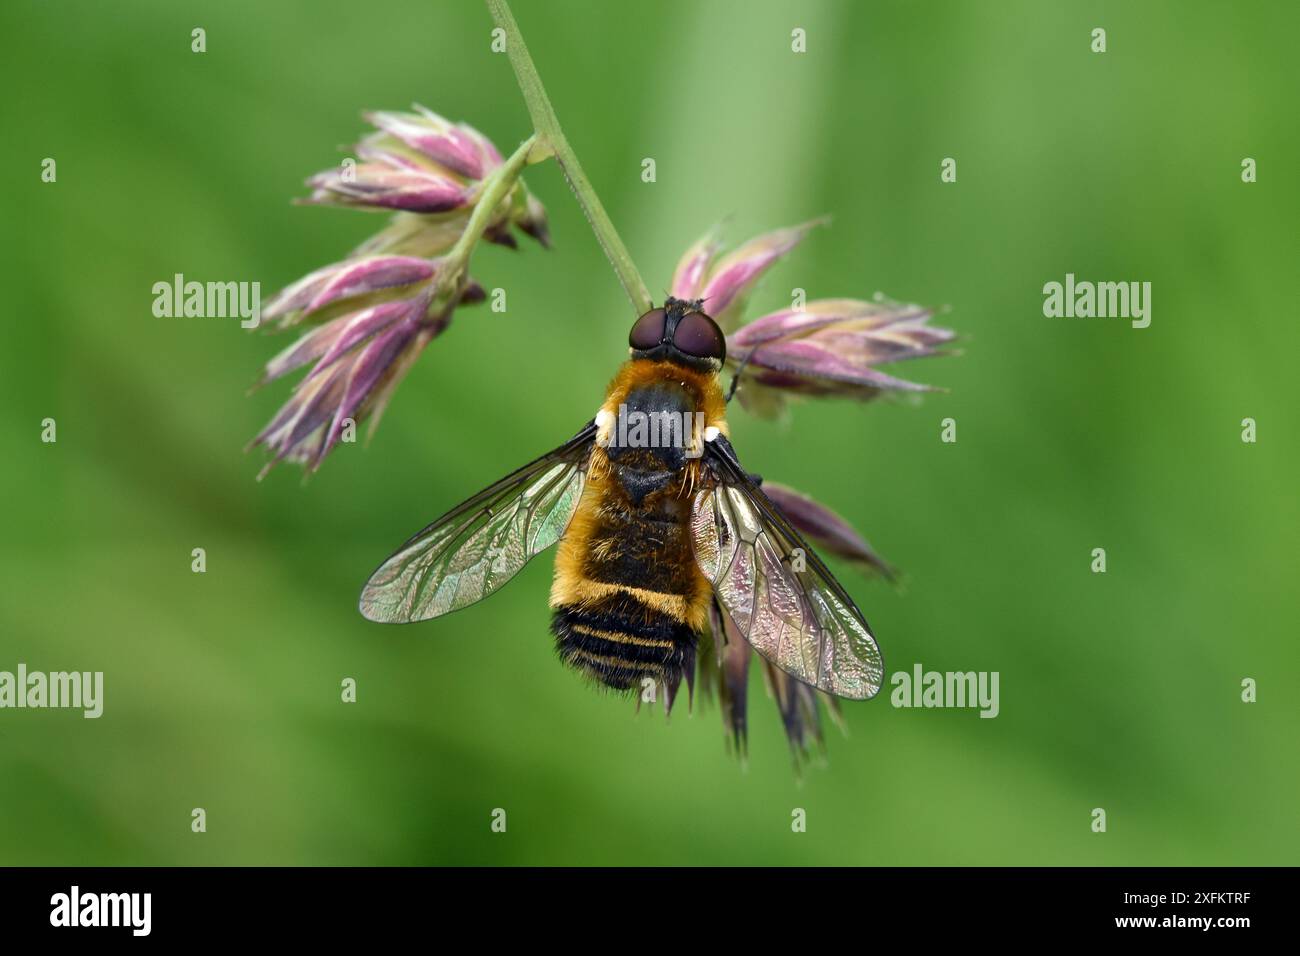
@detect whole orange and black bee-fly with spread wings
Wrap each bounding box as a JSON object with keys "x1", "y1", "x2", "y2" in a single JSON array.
[{"x1": 360, "y1": 298, "x2": 883, "y2": 698}]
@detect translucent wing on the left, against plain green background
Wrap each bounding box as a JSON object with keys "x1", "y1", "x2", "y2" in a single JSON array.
[{"x1": 360, "y1": 423, "x2": 595, "y2": 623}]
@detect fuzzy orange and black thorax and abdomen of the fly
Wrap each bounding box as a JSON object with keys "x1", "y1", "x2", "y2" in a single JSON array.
[{"x1": 551, "y1": 360, "x2": 727, "y2": 691}]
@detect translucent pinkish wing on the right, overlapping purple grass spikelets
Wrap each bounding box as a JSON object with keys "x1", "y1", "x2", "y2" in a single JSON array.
[{"x1": 690, "y1": 437, "x2": 884, "y2": 700}]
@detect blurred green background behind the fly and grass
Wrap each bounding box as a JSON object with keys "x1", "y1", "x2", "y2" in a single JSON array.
[{"x1": 0, "y1": 0, "x2": 1300, "y2": 864}]
